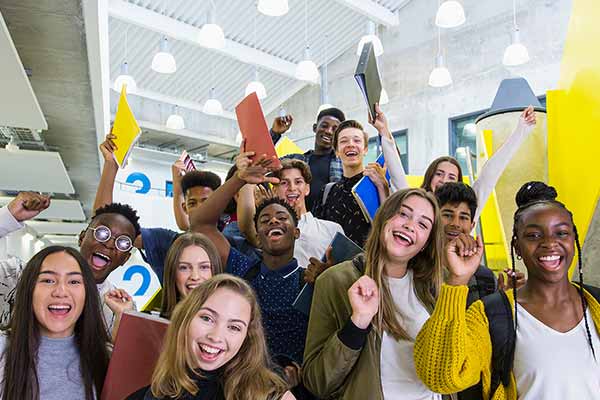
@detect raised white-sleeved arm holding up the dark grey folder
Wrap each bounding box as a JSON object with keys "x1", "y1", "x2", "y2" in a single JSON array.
[{"x1": 369, "y1": 104, "x2": 408, "y2": 190}]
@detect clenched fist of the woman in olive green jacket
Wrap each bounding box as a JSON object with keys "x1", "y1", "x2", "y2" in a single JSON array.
[{"x1": 348, "y1": 275, "x2": 379, "y2": 329}]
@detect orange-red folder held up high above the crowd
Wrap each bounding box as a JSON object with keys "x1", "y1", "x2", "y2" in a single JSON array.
[{"x1": 235, "y1": 92, "x2": 281, "y2": 168}]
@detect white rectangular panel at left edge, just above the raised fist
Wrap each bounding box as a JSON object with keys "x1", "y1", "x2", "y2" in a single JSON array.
[{"x1": 0, "y1": 149, "x2": 75, "y2": 194}]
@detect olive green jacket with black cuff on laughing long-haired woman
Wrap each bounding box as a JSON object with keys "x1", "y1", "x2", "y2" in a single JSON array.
[{"x1": 302, "y1": 256, "x2": 383, "y2": 400}]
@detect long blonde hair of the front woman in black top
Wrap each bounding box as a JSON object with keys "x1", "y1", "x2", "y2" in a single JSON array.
[{"x1": 151, "y1": 274, "x2": 288, "y2": 400}]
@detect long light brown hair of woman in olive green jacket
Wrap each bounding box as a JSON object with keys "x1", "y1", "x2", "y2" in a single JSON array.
[{"x1": 365, "y1": 189, "x2": 443, "y2": 340}]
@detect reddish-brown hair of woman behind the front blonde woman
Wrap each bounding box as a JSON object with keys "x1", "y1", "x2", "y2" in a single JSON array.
[{"x1": 160, "y1": 232, "x2": 224, "y2": 319}]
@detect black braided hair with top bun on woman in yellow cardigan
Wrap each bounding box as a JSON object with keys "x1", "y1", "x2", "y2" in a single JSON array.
[{"x1": 510, "y1": 181, "x2": 596, "y2": 359}]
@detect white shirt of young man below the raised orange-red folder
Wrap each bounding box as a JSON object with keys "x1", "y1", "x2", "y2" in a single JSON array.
[{"x1": 294, "y1": 211, "x2": 344, "y2": 268}]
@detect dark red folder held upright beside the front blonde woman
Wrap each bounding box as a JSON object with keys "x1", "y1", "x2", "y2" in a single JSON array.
[{"x1": 100, "y1": 311, "x2": 169, "y2": 400}]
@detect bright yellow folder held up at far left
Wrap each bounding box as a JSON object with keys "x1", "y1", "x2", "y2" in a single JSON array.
[{"x1": 112, "y1": 85, "x2": 142, "y2": 168}]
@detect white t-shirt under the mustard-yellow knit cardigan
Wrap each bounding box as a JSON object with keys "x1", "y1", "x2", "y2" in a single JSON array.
[{"x1": 513, "y1": 307, "x2": 600, "y2": 400}]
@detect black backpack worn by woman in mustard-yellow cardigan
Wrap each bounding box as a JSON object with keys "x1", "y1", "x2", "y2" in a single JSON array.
[{"x1": 458, "y1": 285, "x2": 600, "y2": 400}]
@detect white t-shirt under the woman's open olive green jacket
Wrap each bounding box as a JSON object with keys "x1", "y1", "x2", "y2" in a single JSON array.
[{"x1": 381, "y1": 270, "x2": 442, "y2": 400}]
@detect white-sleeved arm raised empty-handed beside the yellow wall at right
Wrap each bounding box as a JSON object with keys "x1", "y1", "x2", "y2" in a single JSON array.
[{"x1": 473, "y1": 106, "x2": 536, "y2": 221}]
